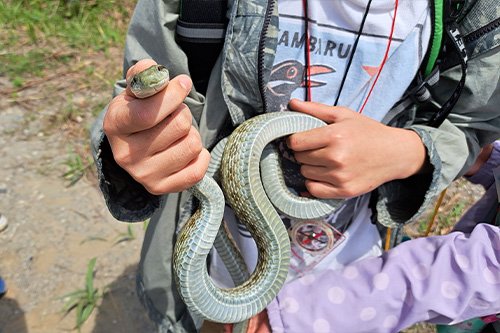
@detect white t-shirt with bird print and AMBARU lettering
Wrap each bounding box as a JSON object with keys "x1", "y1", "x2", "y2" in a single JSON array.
[{"x1": 210, "y1": 0, "x2": 431, "y2": 287}]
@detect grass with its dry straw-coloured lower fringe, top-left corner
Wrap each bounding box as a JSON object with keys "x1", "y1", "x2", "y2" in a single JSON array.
[{"x1": 0, "y1": 0, "x2": 135, "y2": 83}]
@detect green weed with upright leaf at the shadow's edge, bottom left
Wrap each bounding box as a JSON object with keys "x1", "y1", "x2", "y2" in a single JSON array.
[{"x1": 63, "y1": 258, "x2": 104, "y2": 332}]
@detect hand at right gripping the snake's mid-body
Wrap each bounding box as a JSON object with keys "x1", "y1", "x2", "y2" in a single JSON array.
[{"x1": 287, "y1": 99, "x2": 427, "y2": 199}]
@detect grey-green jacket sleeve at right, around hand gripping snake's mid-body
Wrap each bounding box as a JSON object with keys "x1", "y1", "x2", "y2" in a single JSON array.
[{"x1": 375, "y1": 47, "x2": 500, "y2": 226}]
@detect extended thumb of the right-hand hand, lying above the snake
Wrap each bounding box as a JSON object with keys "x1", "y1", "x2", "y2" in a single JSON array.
[{"x1": 288, "y1": 98, "x2": 356, "y2": 124}]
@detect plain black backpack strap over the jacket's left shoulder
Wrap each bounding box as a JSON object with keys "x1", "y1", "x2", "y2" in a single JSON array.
[{"x1": 175, "y1": 0, "x2": 227, "y2": 94}]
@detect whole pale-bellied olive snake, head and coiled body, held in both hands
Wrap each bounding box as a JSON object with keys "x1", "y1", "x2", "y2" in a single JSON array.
[{"x1": 128, "y1": 65, "x2": 341, "y2": 323}]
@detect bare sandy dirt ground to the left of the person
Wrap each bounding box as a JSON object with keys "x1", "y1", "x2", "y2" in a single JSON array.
[{"x1": 0, "y1": 64, "x2": 153, "y2": 333}]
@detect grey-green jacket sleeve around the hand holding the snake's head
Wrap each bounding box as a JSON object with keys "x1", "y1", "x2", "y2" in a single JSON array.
[{"x1": 91, "y1": 0, "x2": 204, "y2": 221}]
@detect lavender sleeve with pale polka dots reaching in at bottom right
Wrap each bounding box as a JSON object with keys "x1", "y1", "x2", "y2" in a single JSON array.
[{"x1": 267, "y1": 224, "x2": 500, "y2": 332}]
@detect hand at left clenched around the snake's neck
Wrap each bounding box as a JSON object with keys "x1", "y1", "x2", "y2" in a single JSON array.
[{"x1": 103, "y1": 59, "x2": 210, "y2": 195}]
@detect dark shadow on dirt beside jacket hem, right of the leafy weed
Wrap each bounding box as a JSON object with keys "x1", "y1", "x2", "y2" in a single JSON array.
[{"x1": 91, "y1": 265, "x2": 156, "y2": 333}]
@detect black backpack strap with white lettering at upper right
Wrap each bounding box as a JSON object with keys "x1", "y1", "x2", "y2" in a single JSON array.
[{"x1": 406, "y1": 0, "x2": 500, "y2": 127}]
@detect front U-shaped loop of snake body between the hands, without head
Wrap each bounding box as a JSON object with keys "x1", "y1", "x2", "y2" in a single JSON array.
[{"x1": 173, "y1": 111, "x2": 325, "y2": 323}]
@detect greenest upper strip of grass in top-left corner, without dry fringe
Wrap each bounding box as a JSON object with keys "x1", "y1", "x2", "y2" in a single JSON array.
[{"x1": 0, "y1": 0, "x2": 131, "y2": 50}]
